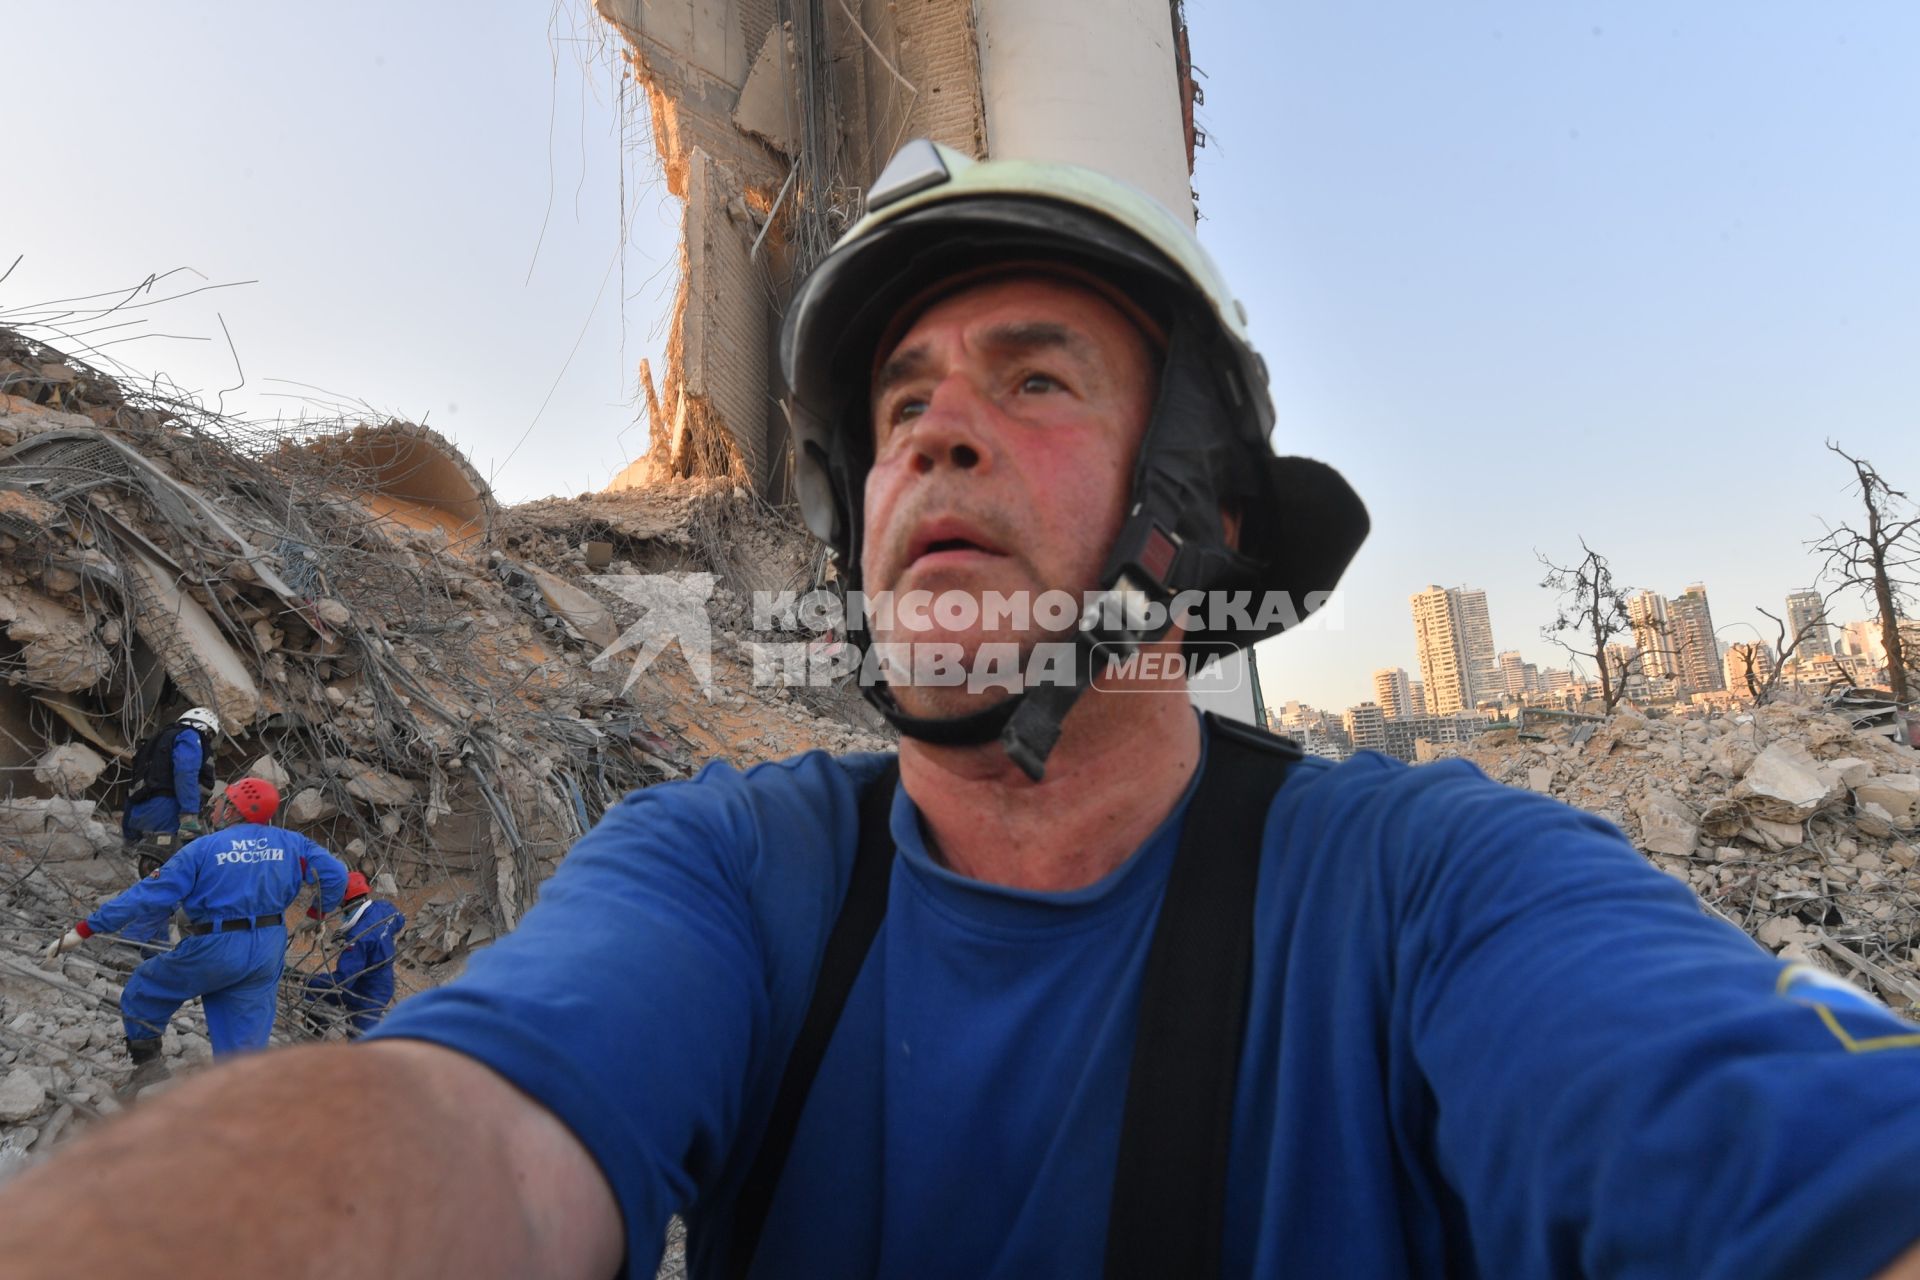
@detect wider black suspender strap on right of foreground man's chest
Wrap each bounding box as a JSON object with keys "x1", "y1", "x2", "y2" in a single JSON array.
[{"x1": 1106, "y1": 714, "x2": 1300, "y2": 1280}]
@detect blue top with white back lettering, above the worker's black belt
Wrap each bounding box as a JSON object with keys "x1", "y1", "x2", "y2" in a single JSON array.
[{"x1": 86, "y1": 825, "x2": 348, "y2": 933}]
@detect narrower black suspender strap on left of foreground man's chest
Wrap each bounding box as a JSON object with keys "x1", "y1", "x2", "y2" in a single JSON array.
[{"x1": 728, "y1": 760, "x2": 900, "y2": 1276}]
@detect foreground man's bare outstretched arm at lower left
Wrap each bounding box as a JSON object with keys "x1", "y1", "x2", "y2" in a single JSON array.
[{"x1": 0, "y1": 1040, "x2": 624, "y2": 1278}]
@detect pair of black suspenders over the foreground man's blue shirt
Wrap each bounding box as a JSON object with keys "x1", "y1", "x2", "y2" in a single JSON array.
[{"x1": 730, "y1": 714, "x2": 1300, "y2": 1280}]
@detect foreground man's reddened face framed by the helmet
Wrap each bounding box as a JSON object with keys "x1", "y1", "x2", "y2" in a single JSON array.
[{"x1": 860, "y1": 276, "x2": 1154, "y2": 716}]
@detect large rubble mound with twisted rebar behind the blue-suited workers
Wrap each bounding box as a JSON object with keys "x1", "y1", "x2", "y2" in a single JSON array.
[{"x1": 0, "y1": 330, "x2": 887, "y2": 1151}]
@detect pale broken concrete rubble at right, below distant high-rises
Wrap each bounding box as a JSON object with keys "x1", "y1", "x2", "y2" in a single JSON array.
[{"x1": 1459, "y1": 702, "x2": 1920, "y2": 1015}]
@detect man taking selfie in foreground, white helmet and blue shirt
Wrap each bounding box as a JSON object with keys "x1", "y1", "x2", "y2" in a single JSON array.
[{"x1": 0, "y1": 144, "x2": 1920, "y2": 1278}]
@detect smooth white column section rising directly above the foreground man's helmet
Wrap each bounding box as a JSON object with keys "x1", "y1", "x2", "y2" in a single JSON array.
[{"x1": 977, "y1": 0, "x2": 1192, "y2": 226}]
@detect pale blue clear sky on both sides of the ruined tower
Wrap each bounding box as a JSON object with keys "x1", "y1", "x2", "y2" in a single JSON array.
[{"x1": 0, "y1": 0, "x2": 1920, "y2": 708}]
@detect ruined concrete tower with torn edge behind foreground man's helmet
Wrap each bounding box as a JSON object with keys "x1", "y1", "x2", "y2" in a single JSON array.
[{"x1": 595, "y1": 0, "x2": 1202, "y2": 501}]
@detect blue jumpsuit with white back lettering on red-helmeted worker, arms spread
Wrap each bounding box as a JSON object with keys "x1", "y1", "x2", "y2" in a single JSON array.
[{"x1": 86, "y1": 823, "x2": 348, "y2": 1054}]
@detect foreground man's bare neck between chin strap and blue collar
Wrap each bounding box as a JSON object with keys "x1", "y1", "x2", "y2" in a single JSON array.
[{"x1": 900, "y1": 689, "x2": 1200, "y2": 892}]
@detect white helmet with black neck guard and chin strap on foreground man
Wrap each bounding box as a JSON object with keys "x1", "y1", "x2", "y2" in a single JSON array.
[{"x1": 780, "y1": 140, "x2": 1367, "y2": 777}]
